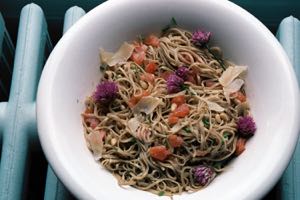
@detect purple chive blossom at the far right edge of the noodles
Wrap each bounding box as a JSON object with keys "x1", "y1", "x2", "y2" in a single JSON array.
[{"x1": 237, "y1": 116, "x2": 256, "y2": 137}]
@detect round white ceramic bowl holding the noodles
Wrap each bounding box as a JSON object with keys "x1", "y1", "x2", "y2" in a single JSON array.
[{"x1": 37, "y1": 0, "x2": 299, "y2": 200}]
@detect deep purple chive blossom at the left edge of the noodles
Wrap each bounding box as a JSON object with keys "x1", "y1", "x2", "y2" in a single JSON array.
[{"x1": 93, "y1": 81, "x2": 119, "y2": 104}]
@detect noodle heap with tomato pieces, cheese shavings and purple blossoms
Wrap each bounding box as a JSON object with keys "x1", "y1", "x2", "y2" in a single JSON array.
[{"x1": 82, "y1": 25, "x2": 256, "y2": 196}]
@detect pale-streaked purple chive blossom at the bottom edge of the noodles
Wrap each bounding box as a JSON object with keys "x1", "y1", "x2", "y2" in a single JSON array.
[{"x1": 193, "y1": 165, "x2": 216, "y2": 186}]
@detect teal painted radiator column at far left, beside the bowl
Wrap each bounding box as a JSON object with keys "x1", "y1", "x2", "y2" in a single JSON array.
[{"x1": 0, "y1": 4, "x2": 48, "y2": 200}]
